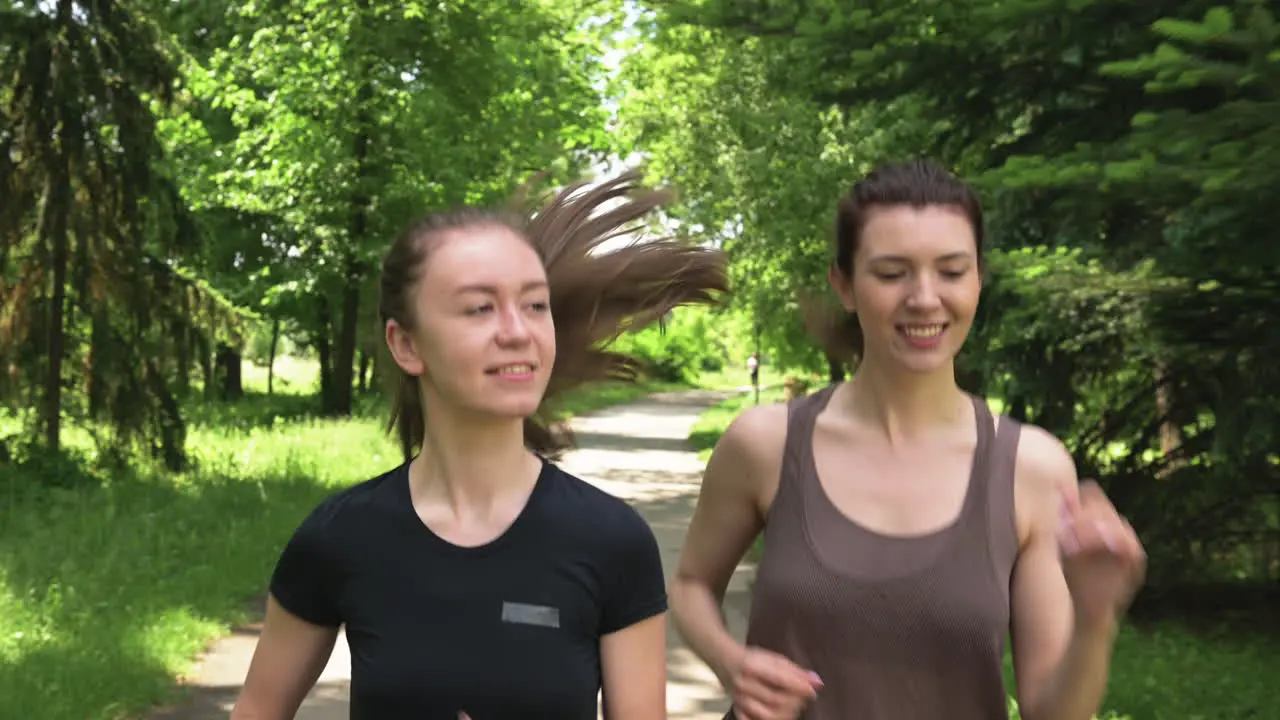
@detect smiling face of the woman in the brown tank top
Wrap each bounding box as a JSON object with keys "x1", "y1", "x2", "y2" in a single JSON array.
[{"x1": 829, "y1": 199, "x2": 982, "y2": 373}]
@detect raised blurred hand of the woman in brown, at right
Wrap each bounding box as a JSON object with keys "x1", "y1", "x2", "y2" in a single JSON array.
[{"x1": 1057, "y1": 480, "x2": 1147, "y2": 628}]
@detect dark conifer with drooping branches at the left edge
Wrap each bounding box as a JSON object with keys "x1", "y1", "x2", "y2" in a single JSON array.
[{"x1": 0, "y1": 0, "x2": 250, "y2": 461}]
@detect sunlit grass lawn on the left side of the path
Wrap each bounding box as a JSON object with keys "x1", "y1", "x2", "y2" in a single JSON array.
[{"x1": 0, "y1": 360, "x2": 691, "y2": 720}]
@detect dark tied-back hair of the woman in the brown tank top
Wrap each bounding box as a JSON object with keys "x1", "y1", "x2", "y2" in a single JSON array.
[{"x1": 803, "y1": 159, "x2": 984, "y2": 363}]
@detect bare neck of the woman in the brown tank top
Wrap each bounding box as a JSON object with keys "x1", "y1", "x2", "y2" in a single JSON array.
[{"x1": 844, "y1": 357, "x2": 966, "y2": 446}]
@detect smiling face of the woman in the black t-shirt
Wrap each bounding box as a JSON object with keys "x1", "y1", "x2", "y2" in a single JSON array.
[{"x1": 387, "y1": 224, "x2": 556, "y2": 419}]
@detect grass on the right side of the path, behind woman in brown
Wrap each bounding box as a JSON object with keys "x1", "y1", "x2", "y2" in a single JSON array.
[{"x1": 690, "y1": 389, "x2": 1280, "y2": 720}]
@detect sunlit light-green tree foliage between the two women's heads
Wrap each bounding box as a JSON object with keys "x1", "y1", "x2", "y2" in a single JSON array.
[{"x1": 618, "y1": 20, "x2": 936, "y2": 368}]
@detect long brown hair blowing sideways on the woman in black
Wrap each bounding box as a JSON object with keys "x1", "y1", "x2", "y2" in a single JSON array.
[{"x1": 379, "y1": 170, "x2": 728, "y2": 460}]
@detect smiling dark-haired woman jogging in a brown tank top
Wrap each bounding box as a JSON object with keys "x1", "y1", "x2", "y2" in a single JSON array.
[{"x1": 671, "y1": 161, "x2": 1146, "y2": 720}]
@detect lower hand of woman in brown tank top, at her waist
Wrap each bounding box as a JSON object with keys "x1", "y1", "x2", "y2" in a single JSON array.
[{"x1": 732, "y1": 647, "x2": 822, "y2": 720}]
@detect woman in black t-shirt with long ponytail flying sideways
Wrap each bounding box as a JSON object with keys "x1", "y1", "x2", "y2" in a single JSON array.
[{"x1": 232, "y1": 173, "x2": 726, "y2": 720}]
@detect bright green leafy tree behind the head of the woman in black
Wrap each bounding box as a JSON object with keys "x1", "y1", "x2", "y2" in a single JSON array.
[{"x1": 153, "y1": 0, "x2": 619, "y2": 414}]
